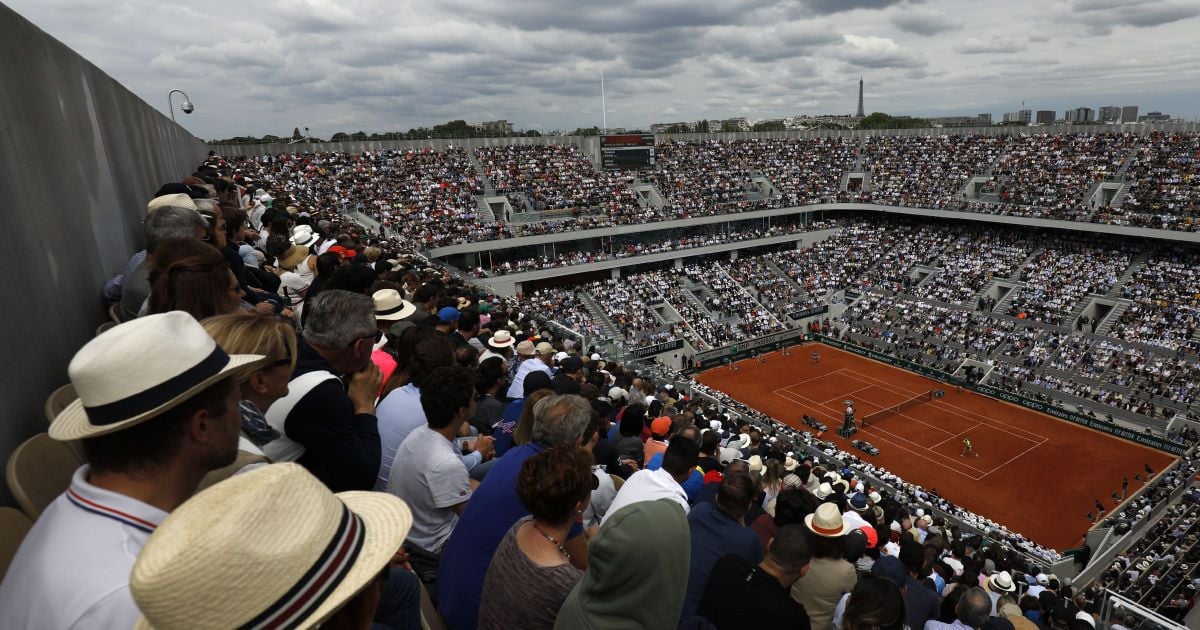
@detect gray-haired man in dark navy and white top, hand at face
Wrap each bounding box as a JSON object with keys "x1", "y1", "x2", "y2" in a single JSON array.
[{"x1": 266, "y1": 289, "x2": 383, "y2": 492}]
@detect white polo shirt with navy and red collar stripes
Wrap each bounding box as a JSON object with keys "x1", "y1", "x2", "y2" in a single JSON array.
[{"x1": 0, "y1": 466, "x2": 167, "y2": 629}]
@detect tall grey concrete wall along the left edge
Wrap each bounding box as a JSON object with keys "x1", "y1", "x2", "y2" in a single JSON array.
[{"x1": 0, "y1": 0, "x2": 208, "y2": 503}]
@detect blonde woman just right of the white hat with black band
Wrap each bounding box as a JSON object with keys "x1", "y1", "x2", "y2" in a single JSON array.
[{"x1": 200, "y1": 312, "x2": 305, "y2": 462}]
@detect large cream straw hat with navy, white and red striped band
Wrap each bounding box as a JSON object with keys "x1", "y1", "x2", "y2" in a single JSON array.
[{"x1": 130, "y1": 463, "x2": 413, "y2": 629}]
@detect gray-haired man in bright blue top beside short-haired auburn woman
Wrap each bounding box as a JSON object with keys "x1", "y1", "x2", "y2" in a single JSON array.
[{"x1": 438, "y1": 394, "x2": 594, "y2": 630}]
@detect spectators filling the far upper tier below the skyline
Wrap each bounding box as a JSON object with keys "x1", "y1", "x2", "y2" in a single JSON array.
[{"x1": 201, "y1": 131, "x2": 1200, "y2": 259}]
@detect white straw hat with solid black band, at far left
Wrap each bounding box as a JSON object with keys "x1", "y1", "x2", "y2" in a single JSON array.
[{"x1": 50, "y1": 311, "x2": 266, "y2": 442}]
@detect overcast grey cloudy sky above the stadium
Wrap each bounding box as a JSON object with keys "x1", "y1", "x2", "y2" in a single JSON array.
[{"x1": 4, "y1": 0, "x2": 1200, "y2": 138}]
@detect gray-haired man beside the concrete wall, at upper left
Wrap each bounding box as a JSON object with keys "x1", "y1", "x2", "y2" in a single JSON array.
[{"x1": 112, "y1": 199, "x2": 208, "y2": 322}]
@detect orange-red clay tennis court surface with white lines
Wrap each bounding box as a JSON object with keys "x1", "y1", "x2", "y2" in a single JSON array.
[{"x1": 696, "y1": 343, "x2": 1174, "y2": 551}]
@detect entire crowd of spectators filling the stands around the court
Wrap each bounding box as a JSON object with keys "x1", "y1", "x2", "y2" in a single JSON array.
[{"x1": 7, "y1": 125, "x2": 1200, "y2": 630}]
